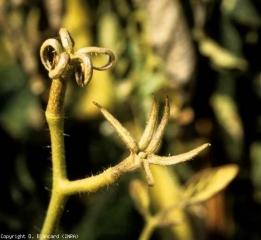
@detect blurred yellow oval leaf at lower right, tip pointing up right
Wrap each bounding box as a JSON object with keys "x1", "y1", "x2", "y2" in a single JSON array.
[{"x1": 182, "y1": 164, "x2": 239, "y2": 204}]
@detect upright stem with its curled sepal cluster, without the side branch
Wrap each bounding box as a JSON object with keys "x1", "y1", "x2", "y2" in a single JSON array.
[{"x1": 40, "y1": 28, "x2": 115, "y2": 236}]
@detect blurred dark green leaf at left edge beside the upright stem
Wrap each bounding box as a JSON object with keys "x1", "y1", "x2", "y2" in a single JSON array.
[{"x1": 0, "y1": 63, "x2": 42, "y2": 139}]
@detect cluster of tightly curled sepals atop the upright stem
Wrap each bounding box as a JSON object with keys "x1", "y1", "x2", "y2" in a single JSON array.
[{"x1": 40, "y1": 28, "x2": 115, "y2": 87}]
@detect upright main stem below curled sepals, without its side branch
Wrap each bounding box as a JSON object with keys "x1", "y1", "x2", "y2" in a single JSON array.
[{"x1": 41, "y1": 78, "x2": 67, "y2": 239}]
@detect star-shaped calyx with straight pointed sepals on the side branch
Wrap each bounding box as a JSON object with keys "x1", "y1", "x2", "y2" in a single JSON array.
[{"x1": 94, "y1": 96, "x2": 210, "y2": 186}]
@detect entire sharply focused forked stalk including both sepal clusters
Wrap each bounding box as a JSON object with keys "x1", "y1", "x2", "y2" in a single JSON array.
[{"x1": 40, "y1": 28, "x2": 209, "y2": 239}]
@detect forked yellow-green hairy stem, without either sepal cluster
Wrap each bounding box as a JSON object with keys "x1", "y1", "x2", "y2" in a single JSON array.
[{"x1": 40, "y1": 78, "x2": 138, "y2": 236}]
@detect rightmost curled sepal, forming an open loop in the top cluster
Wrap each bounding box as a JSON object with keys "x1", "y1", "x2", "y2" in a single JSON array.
[{"x1": 75, "y1": 47, "x2": 115, "y2": 71}]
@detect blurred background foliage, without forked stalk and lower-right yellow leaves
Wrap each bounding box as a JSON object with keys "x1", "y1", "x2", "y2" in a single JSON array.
[{"x1": 0, "y1": 0, "x2": 261, "y2": 240}]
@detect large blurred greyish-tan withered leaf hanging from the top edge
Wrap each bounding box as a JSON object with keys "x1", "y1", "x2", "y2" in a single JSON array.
[{"x1": 134, "y1": 0, "x2": 195, "y2": 85}]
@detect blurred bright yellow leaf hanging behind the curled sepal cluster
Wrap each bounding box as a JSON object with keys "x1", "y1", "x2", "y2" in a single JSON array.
[{"x1": 63, "y1": 0, "x2": 114, "y2": 119}]
